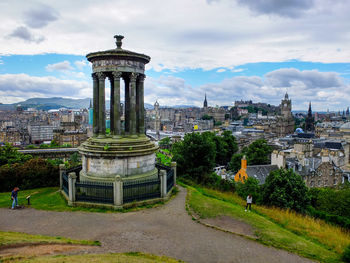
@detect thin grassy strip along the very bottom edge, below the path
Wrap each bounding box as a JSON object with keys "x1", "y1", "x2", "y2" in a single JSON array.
[{"x1": 3, "y1": 252, "x2": 183, "y2": 263}]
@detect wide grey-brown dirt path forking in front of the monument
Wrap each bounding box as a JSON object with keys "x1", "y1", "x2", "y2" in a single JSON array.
[{"x1": 0, "y1": 188, "x2": 312, "y2": 263}]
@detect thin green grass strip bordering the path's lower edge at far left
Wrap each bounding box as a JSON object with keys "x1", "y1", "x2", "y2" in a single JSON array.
[{"x1": 0, "y1": 231, "x2": 101, "y2": 248}]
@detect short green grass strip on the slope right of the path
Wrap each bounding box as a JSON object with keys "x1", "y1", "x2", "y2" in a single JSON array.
[{"x1": 187, "y1": 187, "x2": 340, "y2": 262}]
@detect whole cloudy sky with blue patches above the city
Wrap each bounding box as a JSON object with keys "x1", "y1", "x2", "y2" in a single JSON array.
[{"x1": 0, "y1": 0, "x2": 350, "y2": 111}]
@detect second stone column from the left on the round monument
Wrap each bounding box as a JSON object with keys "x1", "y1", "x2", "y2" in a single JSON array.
[{"x1": 97, "y1": 72, "x2": 106, "y2": 138}]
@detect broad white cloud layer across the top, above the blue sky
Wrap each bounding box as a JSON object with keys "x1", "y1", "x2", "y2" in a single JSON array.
[{"x1": 0, "y1": 0, "x2": 350, "y2": 70}]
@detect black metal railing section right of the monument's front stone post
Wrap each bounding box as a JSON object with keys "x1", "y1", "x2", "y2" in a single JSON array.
[{"x1": 123, "y1": 178, "x2": 161, "y2": 203}]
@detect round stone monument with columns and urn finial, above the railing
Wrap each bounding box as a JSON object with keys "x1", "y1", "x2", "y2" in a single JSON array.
[{"x1": 78, "y1": 35, "x2": 158, "y2": 182}]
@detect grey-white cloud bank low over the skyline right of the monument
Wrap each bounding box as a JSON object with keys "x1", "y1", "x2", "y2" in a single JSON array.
[{"x1": 145, "y1": 68, "x2": 350, "y2": 111}]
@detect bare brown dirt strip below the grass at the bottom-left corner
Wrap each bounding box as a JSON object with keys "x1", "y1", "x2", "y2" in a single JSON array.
[{"x1": 0, "y1": 244, "x2": 91, "y2": 259}]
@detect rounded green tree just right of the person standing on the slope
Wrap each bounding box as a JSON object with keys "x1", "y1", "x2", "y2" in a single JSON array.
[{"x1": 262, "y1": 169, "x2": 310, "y2": 212}]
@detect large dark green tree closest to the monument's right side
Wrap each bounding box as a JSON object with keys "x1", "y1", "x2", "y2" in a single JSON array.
[{"x1": 173, "y1": 133, "x2": 216, "y2": 183}]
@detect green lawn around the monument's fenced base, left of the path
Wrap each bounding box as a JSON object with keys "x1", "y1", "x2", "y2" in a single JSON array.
[{"x1": 0, "y1": 187, "x2": 178, "y2": 213}]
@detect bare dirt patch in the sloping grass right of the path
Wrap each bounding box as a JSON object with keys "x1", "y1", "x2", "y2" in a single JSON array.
[{"x1": 200, "y1": 216, "x2": 257, "y2": 238}]
